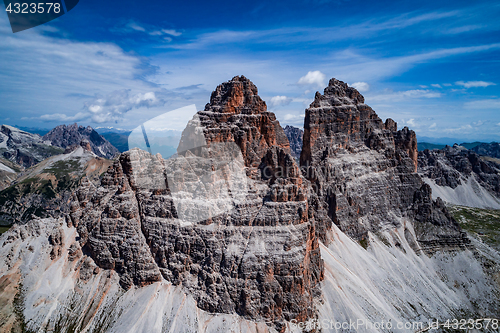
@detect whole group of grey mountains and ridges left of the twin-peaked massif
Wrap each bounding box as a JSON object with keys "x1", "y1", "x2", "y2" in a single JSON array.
[{"x1": 0, "y1": 124, "x2": 119, "y2": 226}]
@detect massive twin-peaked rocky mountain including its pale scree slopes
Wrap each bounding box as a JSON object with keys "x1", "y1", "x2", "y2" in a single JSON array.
[{"x1": 0, "y1": 76, "x2": 500, "y2": 333}]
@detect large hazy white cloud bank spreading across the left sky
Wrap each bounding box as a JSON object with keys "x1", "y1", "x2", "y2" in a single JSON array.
[{"x1": 0, "y1": 16, "x2": 207, "y2": 127}]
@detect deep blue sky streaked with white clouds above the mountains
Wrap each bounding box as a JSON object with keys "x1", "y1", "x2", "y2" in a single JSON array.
[{"x1": 0, "y1": 0, "x2": 500, "y2": 141}]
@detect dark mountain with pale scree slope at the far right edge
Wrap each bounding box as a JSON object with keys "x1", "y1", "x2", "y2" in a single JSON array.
[{"x1": 418, "y1": 144, "x2": 500, "y2": 209}]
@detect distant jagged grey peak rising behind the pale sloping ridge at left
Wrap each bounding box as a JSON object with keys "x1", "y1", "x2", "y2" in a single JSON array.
[{"x1": 43, "y1": 123, "x2": 119, "y2": 159}]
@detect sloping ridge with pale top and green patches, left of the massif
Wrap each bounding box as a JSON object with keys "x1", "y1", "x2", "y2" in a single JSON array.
[{"x1": 0, "y1": 141, "x2": 112, "y2": 225}]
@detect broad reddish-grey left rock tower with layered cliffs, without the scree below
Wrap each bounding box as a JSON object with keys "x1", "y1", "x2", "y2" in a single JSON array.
[{"x1": 71, "y1": 77, "x2": 323, "y2": 330}]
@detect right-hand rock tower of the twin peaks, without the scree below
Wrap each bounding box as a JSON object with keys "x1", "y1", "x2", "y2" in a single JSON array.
[{"x1": 300, "y1": 79, "x2": 468, "y2": 251}]
